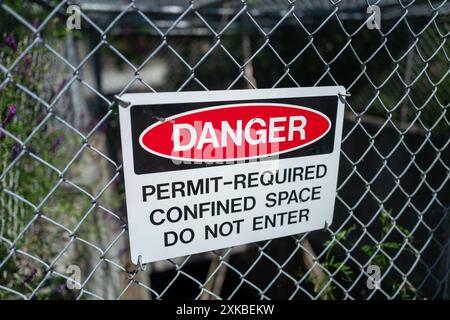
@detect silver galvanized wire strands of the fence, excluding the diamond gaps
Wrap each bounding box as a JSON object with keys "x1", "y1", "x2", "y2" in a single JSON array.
[{"x1": 0, "y1": 0, "x2": 450, "y2": 299}]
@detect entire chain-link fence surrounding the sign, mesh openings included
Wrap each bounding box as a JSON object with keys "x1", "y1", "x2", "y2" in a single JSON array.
[{"x1": 0, "y1": 0, "x2": 450, "y2": 299}]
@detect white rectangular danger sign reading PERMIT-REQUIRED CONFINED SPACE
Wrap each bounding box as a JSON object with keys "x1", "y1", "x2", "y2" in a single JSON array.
[{"x1": 119, "y1": 87, "x2": 345, "y2": 263}]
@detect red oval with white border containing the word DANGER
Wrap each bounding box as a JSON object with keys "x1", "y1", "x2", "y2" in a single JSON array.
[{"x1": 139, "y1": 103, "x2": 331, "y2": 162}]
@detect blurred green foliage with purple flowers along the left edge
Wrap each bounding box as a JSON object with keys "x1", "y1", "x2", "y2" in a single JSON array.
[{"x1": 0, "y1": 1, "x2": 87, "y2": 299}]
